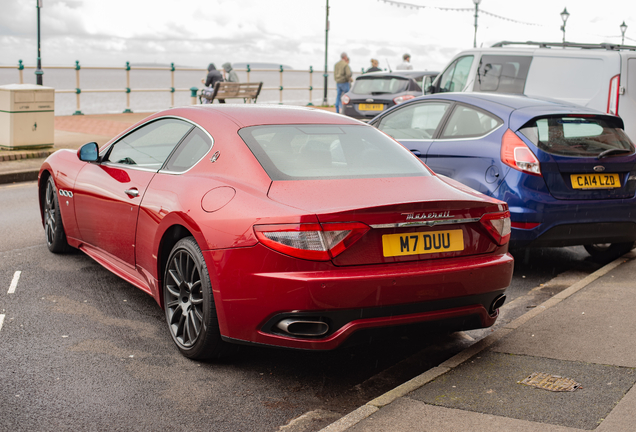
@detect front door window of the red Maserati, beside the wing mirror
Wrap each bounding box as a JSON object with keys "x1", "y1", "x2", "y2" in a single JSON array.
[{"x1": 106, "y1": 119, "x2": 193, "y2": 170}]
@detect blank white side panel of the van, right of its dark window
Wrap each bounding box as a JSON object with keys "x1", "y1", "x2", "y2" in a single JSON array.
[{"x1": 524, "y1": 56, "x2": 609, "y2": 105}]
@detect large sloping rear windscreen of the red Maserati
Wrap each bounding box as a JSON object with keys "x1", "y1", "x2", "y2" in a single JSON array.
[{"x1": 239, "y1": 125, "x2": 431, "y2": 180}]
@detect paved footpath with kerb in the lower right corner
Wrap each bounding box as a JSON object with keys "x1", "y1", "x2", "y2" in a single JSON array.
[{"x1": 322, "y1": 251, "x2": 636, "y2": 432}]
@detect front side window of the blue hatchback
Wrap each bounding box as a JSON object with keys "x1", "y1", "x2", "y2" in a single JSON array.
[{"x1": 378, "y1": 102, "x2": 450, "y2": 140}]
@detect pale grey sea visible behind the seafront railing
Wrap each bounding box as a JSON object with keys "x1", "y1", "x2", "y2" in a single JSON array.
[{"x1": 0, "y1": 66, "x2": 355, "y2": 116}]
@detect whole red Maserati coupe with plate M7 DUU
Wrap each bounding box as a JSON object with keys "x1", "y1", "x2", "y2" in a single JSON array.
[{"x1": 39, "y1": 105, "x2": 513, "y2": 359}]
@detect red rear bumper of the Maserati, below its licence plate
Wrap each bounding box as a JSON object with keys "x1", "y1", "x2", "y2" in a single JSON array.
[{"x1": 204, "y1": 245, "x2": 513, "y2": 350}]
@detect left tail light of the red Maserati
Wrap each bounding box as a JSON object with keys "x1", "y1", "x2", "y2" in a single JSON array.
[{"x1": 254, "y1": 222, "x2": 370, "y2": 261}]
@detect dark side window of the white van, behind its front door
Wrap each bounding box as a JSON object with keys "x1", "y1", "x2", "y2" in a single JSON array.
[{"x1": 474, "y1": 55, "x2": 532, "y2": 94}]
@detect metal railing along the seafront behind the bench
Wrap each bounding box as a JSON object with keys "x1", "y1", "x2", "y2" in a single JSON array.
[{"x1": 0, "y1": 60, "x2": 359, "y2": 115}]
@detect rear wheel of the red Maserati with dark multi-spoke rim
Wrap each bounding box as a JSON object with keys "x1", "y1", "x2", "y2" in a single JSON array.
[{"x1": 163, "y1": 237, "x2": 229, "y2": 360}]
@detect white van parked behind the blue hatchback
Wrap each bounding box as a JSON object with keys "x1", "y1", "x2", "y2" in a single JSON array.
[{"x1": 425, "y1": 42, "x2": 636, "y2": 141}]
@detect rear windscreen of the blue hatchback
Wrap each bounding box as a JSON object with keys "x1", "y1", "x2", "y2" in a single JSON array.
[{"x1": 520, "y1": 116, "x2": 634, "y2": 157}]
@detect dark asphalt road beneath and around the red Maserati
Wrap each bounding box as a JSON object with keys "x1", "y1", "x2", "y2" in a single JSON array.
[{"x1": 0, "y1": 182, "x2": 600, "y2": 431}]
